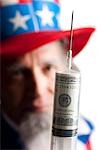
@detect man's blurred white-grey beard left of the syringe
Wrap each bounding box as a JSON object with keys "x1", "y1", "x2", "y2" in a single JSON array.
[{"x1": 20, "y1": 113, "x2": 52, "y2": 150}]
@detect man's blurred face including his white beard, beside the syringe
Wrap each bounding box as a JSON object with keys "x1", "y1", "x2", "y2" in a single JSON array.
[{"x1": 1, "y1": 41, "x2": 66, "y2": 150}]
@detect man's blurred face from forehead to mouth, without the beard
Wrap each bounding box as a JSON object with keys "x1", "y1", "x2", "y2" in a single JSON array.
[{"x1": 2, "y1": 42, "x2": 64, "y2": 123}]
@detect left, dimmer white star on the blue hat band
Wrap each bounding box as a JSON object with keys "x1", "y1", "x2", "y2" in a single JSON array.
[{"x1": 9, "y1": 11, "x2": 30, "y2": 31}]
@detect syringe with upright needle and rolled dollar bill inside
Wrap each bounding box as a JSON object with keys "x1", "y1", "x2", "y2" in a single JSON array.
[{"x1": 51, "y1": 12, "x2": 80, "y2": 150}]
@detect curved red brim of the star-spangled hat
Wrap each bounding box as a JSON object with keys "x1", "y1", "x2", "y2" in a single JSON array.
[{"x1": 0, "y1": 28, "x2": 95, "y2": 57}]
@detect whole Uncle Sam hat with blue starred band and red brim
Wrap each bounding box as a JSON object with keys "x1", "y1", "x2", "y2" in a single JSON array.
[{"x1": 0, "y1": 0, "x2": 94, "y2": 56}]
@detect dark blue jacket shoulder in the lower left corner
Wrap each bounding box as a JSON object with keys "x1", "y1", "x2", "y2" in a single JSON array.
[{"x1": 0, "y1": 115, "x2": 25, "y2": 150}]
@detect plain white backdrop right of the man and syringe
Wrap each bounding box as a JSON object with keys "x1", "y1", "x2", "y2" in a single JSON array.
[{"x1": 60, "y1": 0, "x2": 99, "y2": 150}]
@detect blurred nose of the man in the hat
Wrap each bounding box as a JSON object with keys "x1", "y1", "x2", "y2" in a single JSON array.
[{"x1": 33, "y1": 70, "x2": 48, "y2": 108}]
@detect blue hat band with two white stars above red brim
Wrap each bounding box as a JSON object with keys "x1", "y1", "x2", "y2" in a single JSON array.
[{"x1": 1, "y1": 1, "x2": 60, "y2": 40}]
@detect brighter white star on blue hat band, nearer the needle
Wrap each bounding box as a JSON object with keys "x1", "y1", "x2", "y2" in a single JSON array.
[{"x1": 36, "y1": 5, "x2": 54, "y2": 26}]
